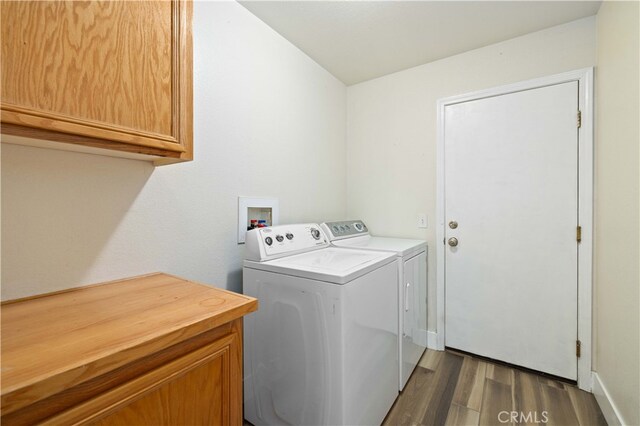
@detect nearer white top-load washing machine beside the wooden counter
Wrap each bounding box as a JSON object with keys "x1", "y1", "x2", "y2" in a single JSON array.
[{"x1": 243, "y1": 224, "x2": 398, "y2": 426}]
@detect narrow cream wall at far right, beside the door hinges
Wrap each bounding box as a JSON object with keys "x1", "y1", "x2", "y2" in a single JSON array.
[{"x1": 595, "y1": 1, "x2": 640, "y2": 425}]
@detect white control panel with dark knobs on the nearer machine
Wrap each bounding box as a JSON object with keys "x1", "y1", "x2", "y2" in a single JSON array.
[{"x1": 245, "y1": 223, "x2": 329, "y2": 262}]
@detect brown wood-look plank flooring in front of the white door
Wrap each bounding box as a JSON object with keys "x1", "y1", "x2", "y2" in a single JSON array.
[{"x1": 383, "y1": 349, "x2": 607, "y2": 426}]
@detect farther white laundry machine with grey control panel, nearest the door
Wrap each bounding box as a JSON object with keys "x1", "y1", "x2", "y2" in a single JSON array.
[{"x1": 321, "y1": 220, "x2": 427, "y2": 390}]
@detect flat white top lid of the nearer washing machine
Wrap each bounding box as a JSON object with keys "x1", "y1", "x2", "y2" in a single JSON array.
[{"x1": 244, "y1": 247, "x2": 396, "y2": 284}]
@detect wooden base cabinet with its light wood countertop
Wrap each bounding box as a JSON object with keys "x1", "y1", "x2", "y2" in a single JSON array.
[{"x1": 2, "y1": 274, "x2": 257, "y2": 424}]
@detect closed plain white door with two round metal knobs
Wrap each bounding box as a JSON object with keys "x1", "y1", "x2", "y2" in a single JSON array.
[{"x1": 444, "y1": 82, "x2": 578, "y2": 380}]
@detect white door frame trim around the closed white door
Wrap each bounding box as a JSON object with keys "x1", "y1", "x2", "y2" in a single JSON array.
[{"x1": 436, "y1": 68, "x2": 594, "y2": 391}]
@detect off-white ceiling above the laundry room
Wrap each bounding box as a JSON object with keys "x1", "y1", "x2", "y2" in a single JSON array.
[{"x1": 240, "y1": 0, "x2": 601, "y2": 85}]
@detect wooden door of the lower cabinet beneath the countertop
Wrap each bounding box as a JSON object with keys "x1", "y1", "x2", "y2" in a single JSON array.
[{"x1": 43, "y1": 328, "x2": 242, "y2": 426}]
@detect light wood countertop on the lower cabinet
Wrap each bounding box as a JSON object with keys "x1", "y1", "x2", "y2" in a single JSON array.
[{"x1": 1, "y1": 273, "x2": 258, "y2": 411}]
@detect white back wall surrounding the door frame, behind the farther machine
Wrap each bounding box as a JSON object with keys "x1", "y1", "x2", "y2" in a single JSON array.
[{"x1": 347, "y1": 17, "x2": 595, "y2": 331}]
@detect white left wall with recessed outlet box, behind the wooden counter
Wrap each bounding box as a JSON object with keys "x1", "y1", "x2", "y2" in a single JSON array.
[{"x1": 2, "y1": 2, "x2": 346, "y2": 299}]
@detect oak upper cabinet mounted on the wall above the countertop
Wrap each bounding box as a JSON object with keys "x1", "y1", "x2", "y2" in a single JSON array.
[{"x1": 1, "y1": 0, "x2": 193, "y2": 163}]
